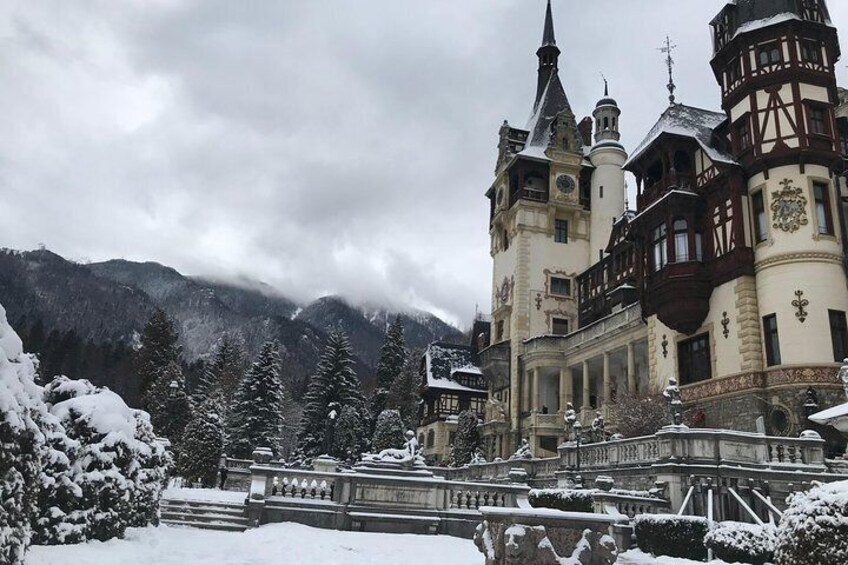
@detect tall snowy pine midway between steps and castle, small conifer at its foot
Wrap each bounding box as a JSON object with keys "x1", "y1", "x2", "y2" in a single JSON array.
[{"x1": 298, "y1": 331, "x2": 369, "y2": 457}]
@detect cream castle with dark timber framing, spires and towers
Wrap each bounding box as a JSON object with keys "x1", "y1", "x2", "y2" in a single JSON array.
[{"x1": 420, "y1": 0, "x2": 848, "y2": 457}]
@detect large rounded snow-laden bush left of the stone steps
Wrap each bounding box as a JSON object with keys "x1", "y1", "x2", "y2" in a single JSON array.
[{"x1": 44, "y1": 377, "x2": 169, "y2": 543}]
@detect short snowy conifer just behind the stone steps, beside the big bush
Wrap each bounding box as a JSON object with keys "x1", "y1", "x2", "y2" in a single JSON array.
[{"x1": 177, "y1": 396, "x2": 224, "y2": 488}]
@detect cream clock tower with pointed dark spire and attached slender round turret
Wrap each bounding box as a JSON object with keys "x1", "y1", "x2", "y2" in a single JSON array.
[{"x1": 484, "y1": 1, "x2": 626, "y2": 450}]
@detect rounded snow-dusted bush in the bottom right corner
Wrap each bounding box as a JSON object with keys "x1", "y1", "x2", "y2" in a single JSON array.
[{"x1": 774, "y1": 481, "x2": 848, "y2": 565}]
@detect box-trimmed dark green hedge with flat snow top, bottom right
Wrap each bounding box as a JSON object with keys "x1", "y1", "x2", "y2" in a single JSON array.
[{"x1": 635, "y1": 514, "x2": 709, "y2": 561}]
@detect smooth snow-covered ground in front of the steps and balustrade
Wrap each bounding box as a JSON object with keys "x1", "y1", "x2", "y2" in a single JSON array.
[{"x1": 26, "y1": 523, "x2": 483, "y2": 565}]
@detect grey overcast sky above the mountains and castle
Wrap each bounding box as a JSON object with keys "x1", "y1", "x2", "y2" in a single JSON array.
[{"x1": 0, "y1": 0, "x2": 848, "y2": 325}]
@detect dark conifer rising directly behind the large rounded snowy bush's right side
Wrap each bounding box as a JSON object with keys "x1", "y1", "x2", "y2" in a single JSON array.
[{"x1": 147, "y1": 362, "x2": 192, "y2": 452}]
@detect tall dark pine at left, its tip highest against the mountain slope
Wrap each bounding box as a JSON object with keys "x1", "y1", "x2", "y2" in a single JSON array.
[{"x1": 134, "y1": 309, "x2": 180, "y2": 408}]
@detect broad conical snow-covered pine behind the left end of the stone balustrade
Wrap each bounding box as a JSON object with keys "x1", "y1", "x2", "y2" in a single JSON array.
[{"x1": 227, "y1": 341, "x2": 285, "y2": 458}]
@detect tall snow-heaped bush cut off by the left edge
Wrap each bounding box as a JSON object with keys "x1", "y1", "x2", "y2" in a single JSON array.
[{"x1": 0, "y1": 305, "x2": 45, "y2": 565}]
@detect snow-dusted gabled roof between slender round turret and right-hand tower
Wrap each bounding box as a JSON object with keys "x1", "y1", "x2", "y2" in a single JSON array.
[{"x1": 624, "y1": 104, "x2": 736, "y2": 168}]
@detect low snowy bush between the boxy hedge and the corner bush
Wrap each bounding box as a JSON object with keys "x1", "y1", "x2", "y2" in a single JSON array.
[{"x1": 704, "y1": 522, "x2": 775, "y2": 565}]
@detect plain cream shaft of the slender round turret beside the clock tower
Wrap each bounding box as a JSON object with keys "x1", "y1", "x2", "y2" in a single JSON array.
[{"x1": 589, "y1": 146, "x2": 627, "y2": 263}]
